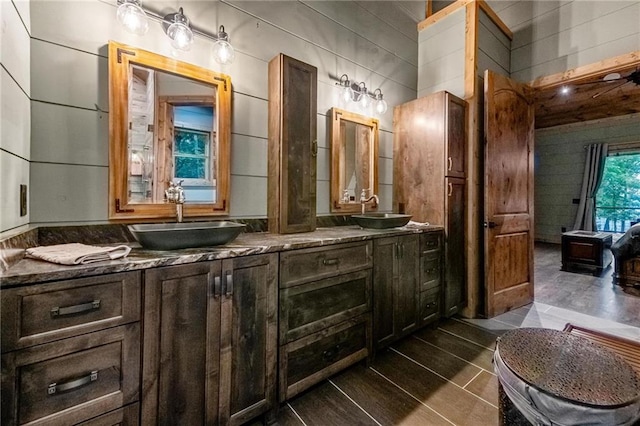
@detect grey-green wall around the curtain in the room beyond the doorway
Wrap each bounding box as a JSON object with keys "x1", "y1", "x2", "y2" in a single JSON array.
[{"x1": 535, "y1": 114, "x2": 640, "y2": 243}]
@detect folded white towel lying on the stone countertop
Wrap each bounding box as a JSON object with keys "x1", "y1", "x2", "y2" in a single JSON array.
[{"x1": 27, "y1": 243, "x2": 131, "y2": 265}]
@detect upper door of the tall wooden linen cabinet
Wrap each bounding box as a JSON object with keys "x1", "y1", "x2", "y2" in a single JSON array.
[{"x1": 445, "y1": 92, "x2": 467, "y2": 178}]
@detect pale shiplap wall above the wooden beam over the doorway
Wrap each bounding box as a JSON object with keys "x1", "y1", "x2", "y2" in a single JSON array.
[{"x1": 488, "y1": 0, "x2": 640, "y2": 82}]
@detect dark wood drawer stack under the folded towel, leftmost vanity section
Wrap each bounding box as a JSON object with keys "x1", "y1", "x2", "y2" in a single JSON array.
[{"x1": 0, "y1": 272, "x2": 141, "y2": 425}]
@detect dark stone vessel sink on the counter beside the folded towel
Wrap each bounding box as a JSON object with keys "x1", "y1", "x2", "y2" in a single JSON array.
[{"x1": 129, "y1": 221, "x2": 245, "y2": 250}]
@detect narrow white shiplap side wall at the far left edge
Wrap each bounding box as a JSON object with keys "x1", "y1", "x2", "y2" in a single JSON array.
[{"x1": 0, "y1": 0, "x2": 31, "y2": 232}]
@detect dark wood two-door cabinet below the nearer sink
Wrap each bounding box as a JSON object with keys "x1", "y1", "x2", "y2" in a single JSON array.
[{"x1": 141, "y1": 254, "x2": 278, "y2": 425}]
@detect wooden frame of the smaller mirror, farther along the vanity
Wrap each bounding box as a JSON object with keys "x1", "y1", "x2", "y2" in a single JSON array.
[{"x1": 331, "y1": 108, "x2": 379, "y2": 213}]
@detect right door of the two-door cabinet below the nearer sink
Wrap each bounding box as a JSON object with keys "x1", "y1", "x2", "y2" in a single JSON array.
[{"x1": 220, "y1": 253, "x2": 278, "y2": 424}]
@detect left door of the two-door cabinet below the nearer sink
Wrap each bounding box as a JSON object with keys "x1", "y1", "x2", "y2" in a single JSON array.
[{"x1": 141, "y1": 261, "x2": 221, "y2": 425}]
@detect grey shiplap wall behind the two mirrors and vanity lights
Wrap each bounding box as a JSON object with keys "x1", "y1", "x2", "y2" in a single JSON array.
[{"x1": 12, "y1": 0, "x2": 424, "y2": 229}]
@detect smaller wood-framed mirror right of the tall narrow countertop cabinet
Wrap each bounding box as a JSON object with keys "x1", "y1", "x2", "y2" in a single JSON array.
[{"x1": 331, "y1": 108, "x2": 378, "y2": 213}]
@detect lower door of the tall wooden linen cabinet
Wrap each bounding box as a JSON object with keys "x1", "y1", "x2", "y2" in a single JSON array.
[{"x1": 443, "y1": 178, "x2": 466, "y2": 317}]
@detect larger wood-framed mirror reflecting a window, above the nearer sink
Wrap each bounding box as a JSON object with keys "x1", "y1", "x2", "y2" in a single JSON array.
[{"x1": 109, "y1": 41, "x2": 231, "y2": 219}]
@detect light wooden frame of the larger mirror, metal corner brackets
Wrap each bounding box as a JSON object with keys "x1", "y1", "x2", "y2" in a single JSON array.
[{"x1": 109, "y1": 41, "x2": 231, "y2": 219}]
